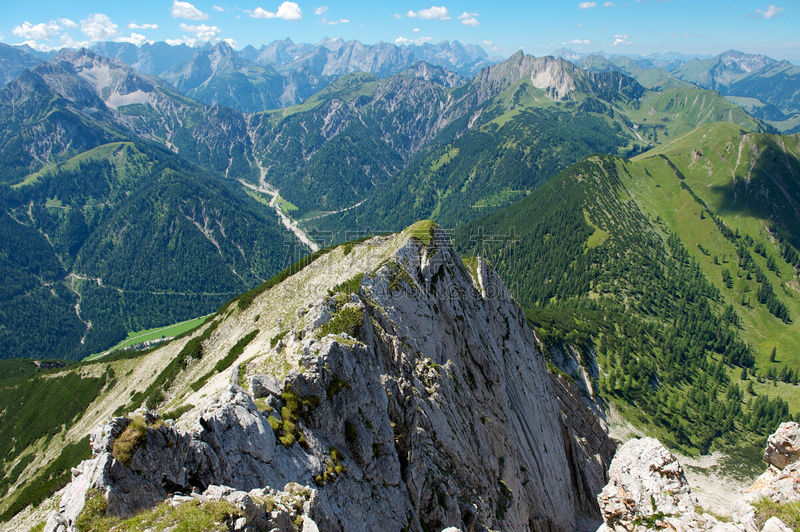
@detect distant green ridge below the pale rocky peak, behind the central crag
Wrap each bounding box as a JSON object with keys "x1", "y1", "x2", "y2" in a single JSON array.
[{"x1": 306, "y1": 80, "x2": 768, "y2": 235}]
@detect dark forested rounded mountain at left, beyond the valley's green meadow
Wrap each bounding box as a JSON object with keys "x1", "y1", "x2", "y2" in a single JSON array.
[{"x1": 0, "y1": 142, "x2": 295, "y2": 358}]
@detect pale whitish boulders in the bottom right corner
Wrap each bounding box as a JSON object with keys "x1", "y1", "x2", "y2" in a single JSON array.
[{"x1": 597, "y1": 422, "x2": 800, "y2": 532}]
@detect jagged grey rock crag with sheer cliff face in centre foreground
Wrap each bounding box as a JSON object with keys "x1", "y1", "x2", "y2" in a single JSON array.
[{"x1": 43, "y1": 226, "x2": 612, "y2": 531}]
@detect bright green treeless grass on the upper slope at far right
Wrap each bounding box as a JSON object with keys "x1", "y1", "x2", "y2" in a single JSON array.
[{"x1": 621, "y1": 124, "x2": 800, "y2": 390}]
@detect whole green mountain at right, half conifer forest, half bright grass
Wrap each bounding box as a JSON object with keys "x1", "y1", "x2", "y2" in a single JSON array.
[{"x1": 454, "y1": 124, "x2": 800, "y2": 452}]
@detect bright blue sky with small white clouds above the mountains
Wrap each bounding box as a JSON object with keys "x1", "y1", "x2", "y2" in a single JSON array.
[{"x1": 0, "y1": 0, "x2": 800, "y2": 61}]
